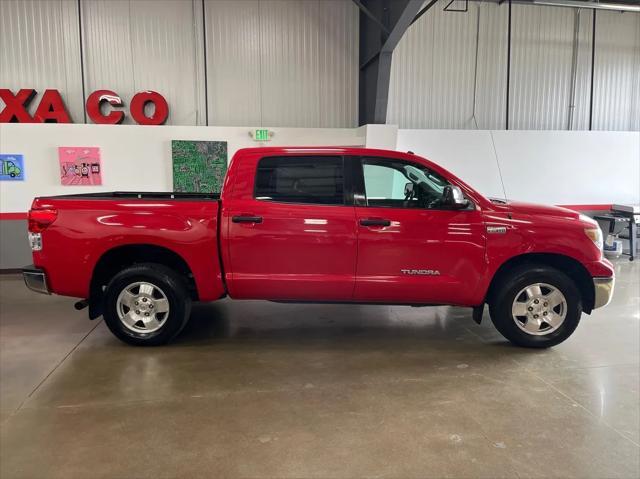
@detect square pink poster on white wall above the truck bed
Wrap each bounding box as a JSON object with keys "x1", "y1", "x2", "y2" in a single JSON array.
[{"x1": 58, "y1": 146, "x2": 102, "y2": 186}]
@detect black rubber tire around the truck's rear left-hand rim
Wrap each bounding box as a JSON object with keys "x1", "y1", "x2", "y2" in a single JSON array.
[{"x1": 103, "y1": 263, "x2": 191, "y2": 346}]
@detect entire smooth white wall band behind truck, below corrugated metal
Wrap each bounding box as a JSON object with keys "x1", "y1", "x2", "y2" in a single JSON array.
[{"x1": 0, "y1": 124, "x2": 640, "y2": 213}]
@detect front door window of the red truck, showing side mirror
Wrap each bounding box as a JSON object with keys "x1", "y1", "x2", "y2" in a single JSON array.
[{"x1": 362, "y1": 158, "x2": 449, "y2": 208}]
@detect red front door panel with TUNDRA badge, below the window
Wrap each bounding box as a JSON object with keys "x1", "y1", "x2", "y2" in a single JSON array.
[{"x1": 354, "y1": 207, "x2": 487, "y2": 304}]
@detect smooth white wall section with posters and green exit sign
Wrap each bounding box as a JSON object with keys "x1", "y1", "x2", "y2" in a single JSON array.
[{"x1": 0, "y1": 123, "x2": 365, "y2": 213}]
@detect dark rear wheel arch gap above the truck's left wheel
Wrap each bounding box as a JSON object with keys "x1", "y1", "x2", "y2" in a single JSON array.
[{"x1": 89, "y1": 243, "x2": 198, "y2": 319}]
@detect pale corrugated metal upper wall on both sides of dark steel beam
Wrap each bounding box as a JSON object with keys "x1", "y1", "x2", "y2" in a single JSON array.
[{"x1": 0, "y1": 0, "x2": 640, "y2": 131}]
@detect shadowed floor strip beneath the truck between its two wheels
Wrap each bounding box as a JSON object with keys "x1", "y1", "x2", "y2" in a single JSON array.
[{"x1": 171, "y1": 300, "x2": 526, "y2": 353}]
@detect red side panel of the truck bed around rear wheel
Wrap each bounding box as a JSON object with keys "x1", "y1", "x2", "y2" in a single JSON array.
[{"x1": 32, "y1": 197, "x2": 224, "y2": 301}]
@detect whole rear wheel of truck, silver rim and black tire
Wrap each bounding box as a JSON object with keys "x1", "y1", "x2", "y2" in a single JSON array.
[{"x1": 104, "y1": 263, "x2": 191, "y2": 346}]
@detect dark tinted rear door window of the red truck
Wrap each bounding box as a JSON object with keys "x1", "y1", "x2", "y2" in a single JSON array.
[{"x1": 255, "y1": 156, "x2": 344, "y2": 205}]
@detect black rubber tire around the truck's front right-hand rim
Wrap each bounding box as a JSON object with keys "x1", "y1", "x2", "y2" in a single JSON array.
[{"x1": 489, "y1": 264, "x2": 582, "y2": 348}]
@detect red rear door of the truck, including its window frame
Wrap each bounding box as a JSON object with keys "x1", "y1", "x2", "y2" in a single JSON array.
[{"x1": 221, "y1": 148, "x2": 357, "y2": 301}]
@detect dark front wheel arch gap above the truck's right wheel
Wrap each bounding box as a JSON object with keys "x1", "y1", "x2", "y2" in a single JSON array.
[{"x1": 485, "y1": 253, "x2": 595, "y2": 314}]
